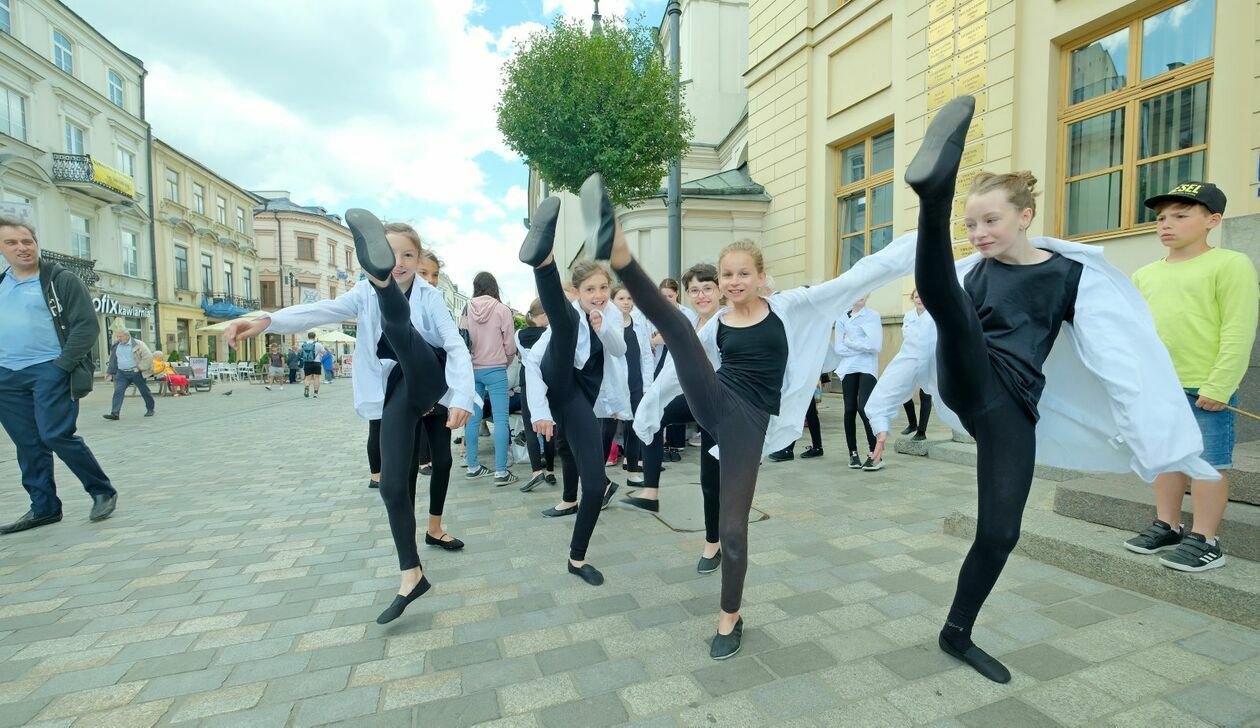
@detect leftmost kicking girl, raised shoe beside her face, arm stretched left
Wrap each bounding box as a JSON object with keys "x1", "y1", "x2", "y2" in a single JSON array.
[{"x1": 224, "y1": 216, "x2": 474, "y2": 625}]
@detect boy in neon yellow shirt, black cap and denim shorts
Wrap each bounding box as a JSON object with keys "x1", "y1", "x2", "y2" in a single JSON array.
[{"x1": 1124, "y1": 181, "x2": 1260, "y2": 572}]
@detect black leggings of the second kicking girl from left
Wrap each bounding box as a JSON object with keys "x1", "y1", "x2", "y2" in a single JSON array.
[{"x1": 534, "y1": 263, "x2": 607, "y2": 562}]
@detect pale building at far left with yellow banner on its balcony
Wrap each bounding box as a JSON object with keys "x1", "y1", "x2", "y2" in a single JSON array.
[{"x1": 0, "y1": 0, "x2": 156, "y2": 359}]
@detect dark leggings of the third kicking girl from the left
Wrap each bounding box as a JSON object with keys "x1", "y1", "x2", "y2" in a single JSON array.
[{"x1": 617, "y1": 261, "x2": 770, "y2": 613}]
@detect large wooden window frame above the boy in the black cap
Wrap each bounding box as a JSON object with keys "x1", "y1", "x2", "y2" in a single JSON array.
[{"x1": 1055, "y1": 0, "x2": 1221, "y2": 243}]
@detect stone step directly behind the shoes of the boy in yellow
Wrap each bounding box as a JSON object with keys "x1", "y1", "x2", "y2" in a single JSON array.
[{"x1": 1055, "y1": 476, "x2": 1260, "y2": 562}]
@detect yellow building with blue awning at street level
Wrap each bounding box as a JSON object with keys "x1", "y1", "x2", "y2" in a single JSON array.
[{"x1": 152, "y1": 140, "x2": 261, "y2": 361}]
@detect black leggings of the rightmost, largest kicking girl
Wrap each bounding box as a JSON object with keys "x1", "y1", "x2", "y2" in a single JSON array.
[{"x1": 915, "y1": 172, "x2": 1037, "y2": 632}]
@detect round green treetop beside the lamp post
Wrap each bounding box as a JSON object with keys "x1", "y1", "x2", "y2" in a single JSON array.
[{"x1": 495, "y1": 18, "x2": 694, "y2": 205}]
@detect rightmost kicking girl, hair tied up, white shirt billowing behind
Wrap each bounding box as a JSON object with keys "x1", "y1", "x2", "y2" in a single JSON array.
[{"x1": 872, "y1": 97, "x2": 1220, "y2": 683}]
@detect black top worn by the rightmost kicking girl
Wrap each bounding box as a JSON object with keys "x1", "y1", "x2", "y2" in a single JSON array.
[{"x1": 963, "y1": 253, "x2": 1084, "y2": 422}]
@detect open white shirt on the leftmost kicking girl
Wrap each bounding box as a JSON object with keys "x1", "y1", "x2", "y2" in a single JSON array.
[{"x1": 267, "y1": 277, "x2": 475, "y2": 419}]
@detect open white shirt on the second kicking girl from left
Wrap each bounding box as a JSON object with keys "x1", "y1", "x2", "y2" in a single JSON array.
[{"x1": 523, "y1": 301, "x2": 633, "y2": 422}]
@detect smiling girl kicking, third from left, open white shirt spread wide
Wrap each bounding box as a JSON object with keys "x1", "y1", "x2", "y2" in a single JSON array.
[{"x1": 582, "y1": 175, "x2": 917, "y2": 660}]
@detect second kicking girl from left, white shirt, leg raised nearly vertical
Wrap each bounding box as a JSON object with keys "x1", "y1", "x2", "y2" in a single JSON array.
[{"x1": 520, "y1": 198, "x2": 626, "y2": 586}]
